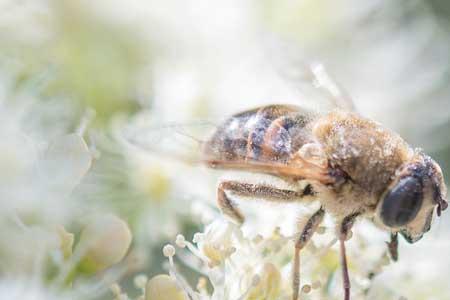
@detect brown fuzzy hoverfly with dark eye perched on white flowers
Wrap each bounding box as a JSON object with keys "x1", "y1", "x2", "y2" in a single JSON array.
[{"x1": 125, "y1": 65, "x2": 448, "y2": 300}]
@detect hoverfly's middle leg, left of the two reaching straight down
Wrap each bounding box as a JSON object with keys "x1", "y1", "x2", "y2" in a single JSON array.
[{"x1": 292, "y1": 208, "x2": 325, "y2": 300}]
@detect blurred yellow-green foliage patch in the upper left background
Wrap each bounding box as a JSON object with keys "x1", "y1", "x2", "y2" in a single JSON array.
[{"x1": 0, "y1": 1, "x2": 150, "y2": 124}]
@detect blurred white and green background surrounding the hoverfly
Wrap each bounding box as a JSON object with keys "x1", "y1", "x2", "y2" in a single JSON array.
[{"x1": 0, "y1": 0, "x2": 450, "y2": 299}]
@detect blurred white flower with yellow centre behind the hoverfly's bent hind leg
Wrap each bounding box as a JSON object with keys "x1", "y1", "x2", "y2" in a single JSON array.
[{"x1": 80, "y1": 115, "x2": 215, "y2": 251}]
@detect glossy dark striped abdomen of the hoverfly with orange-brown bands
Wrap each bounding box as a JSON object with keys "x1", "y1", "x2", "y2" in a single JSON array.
[{"x1": 204, "y1": 105, "x2": 313, "y2": 163}]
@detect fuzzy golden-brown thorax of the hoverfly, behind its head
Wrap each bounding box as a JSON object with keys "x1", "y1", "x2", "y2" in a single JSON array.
[{"x1": 313, "y1": 111, "x2": 413, "y2": 216}]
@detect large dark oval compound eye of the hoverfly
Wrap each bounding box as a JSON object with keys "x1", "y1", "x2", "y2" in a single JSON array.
[{"x1": 380, "y1": 176, "x2": 423, "y2": 227}]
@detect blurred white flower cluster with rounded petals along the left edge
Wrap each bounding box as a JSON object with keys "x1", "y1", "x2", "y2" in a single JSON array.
[{"x1": 0, "y1": 95, "x2": 132, "y2": 300}]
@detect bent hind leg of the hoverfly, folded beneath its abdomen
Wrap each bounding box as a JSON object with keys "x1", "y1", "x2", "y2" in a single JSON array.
[{"x1": 217, "y1": 181, "x2": 314, "y2": 224}]
